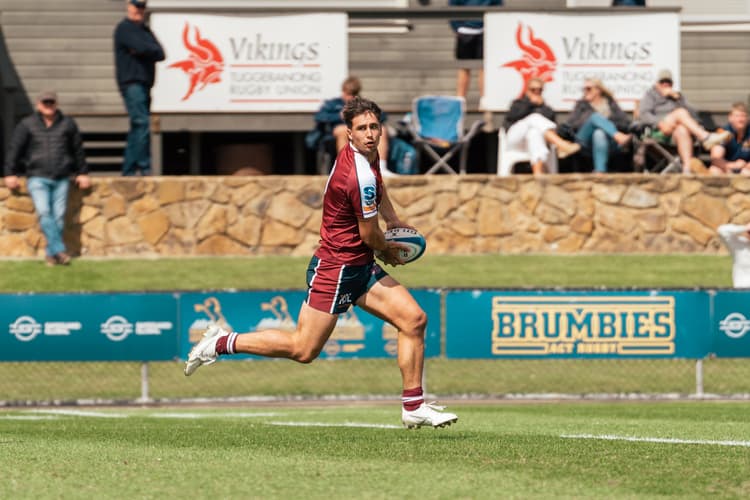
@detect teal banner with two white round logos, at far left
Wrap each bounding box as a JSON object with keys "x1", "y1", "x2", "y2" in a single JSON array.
[{"x1": 0, "y1": 293, "x2": 177, "y2": 361}]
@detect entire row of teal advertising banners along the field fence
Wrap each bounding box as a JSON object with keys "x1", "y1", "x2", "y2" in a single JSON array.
[{"x1": 0, "y1": 290, "x2": 750, "y2": 361}]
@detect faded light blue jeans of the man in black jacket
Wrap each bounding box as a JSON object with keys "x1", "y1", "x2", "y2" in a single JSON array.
[{"x1": 27, "y1": 177, "x2": 70, "y2": 257}]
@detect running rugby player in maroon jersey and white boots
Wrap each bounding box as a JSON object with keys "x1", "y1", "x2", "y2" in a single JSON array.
[{"x1": 185, "y1": 97, "x2": 458, "y2": 428}]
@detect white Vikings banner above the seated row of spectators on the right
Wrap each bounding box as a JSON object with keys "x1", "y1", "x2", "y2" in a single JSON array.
[{"x1": 484, "y1": 9, "x2": 680, "y2": 111}]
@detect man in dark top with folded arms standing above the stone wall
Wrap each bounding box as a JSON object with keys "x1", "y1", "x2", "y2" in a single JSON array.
[{"x1": 114, "y1": 0, "x2": 164, "y2": 175}]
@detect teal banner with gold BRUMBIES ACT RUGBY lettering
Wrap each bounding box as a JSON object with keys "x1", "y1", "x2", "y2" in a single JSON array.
[{"x1": 445, "y1": 290, "x2": 712, "y2": 359}]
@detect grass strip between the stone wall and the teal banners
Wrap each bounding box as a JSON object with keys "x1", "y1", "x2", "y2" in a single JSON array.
[{"x1": 0, "y1": 255, "x2": 732, "y2": 293}]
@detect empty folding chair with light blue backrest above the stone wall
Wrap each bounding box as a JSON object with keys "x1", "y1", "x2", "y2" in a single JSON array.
[{"x1": 409, "y1": 95, "x2": 483, "y2": 174}]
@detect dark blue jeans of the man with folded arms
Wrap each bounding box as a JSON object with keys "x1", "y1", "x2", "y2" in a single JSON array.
[{"x1": 122, "y1": 83, "x2": 151, "y2": 175}]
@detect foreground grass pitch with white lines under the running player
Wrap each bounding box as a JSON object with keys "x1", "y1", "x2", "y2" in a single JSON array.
[{"x1": 0, "y1": 403, "x2": 750, "y2": 499}]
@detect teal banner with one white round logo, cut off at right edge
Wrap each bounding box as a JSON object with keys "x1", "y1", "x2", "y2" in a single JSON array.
[{"x1": 711, "y1": 290, "x2": 750, "y2": 358}]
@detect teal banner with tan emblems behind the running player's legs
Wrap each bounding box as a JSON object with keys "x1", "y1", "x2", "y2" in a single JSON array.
[{"x1": 180, "y1": 290, "x2": 440, "y2": 359}]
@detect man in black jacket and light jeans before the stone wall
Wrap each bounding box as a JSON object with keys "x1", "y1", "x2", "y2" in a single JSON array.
[{"x1": 5, "y1": 91, "x2": 91, "y2": 266}]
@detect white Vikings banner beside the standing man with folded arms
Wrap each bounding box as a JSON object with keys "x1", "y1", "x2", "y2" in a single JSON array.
[{"x1": 151, "y1": 13, "x2": 349, "y2": 112}]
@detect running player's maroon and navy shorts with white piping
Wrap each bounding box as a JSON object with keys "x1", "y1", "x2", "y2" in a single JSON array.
[{"x1": 305, "y1": 256, "x2": 388, "y2": 314}]
